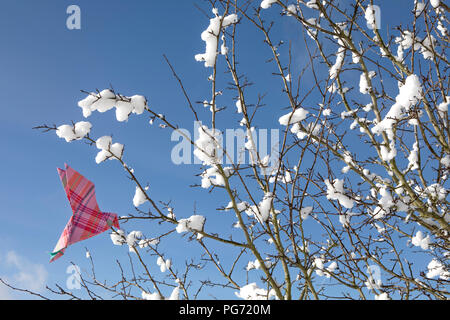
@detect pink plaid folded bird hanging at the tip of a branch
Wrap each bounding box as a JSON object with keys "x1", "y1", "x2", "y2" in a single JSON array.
[{"x1": 50, "y1": 164, "x2": 120, "y2": 262}]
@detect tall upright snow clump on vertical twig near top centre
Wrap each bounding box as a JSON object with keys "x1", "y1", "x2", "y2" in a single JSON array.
[{"x1": 195, "y1": 10, "x2": 238, "y2": 67}]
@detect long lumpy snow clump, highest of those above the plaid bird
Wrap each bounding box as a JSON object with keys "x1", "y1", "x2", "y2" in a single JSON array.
[{"x1": 78, "y1": 89, "x2": 147, "y2": 122}]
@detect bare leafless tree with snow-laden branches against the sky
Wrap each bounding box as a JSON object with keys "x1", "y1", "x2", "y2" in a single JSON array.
[{"x1": 29, "y1": 0, "x2": 450, "y2": 299}]
